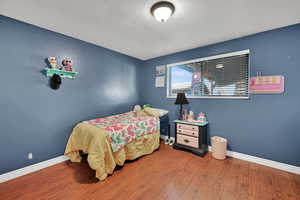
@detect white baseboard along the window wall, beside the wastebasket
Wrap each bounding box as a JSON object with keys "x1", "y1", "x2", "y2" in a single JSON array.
[{"x1": 208, "y1": 146, "x2": 300, "y2": 175}]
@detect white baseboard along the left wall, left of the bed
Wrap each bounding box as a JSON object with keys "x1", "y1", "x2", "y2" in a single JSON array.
[{"x1": 0, "y1": 156, "x2": 69, "y2": 183}]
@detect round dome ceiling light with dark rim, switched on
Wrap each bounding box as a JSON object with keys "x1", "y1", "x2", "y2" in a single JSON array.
[{"x1": 151, "y1": 1, "x2": 175, "y2": 22}]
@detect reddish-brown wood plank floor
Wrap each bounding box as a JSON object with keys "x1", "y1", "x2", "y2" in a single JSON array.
[{"x1": 0, "y1": 144, "x2": 300, "y2": 200}]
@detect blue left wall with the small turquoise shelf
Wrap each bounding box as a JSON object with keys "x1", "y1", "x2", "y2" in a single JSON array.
[{"x1": 0, "y1": 16, "x2": 142, "y2": 174}]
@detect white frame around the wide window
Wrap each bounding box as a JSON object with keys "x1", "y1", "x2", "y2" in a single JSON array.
[{"x1": 166, "y1": 49, "x2": 250, "y2": 99}]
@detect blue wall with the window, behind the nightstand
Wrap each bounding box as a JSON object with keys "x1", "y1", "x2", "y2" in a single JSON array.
[{"x1": 139, "y1": 24, "x2": 300, "y2": 166}]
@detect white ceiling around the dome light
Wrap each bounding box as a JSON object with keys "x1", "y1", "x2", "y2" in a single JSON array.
[{"x1": 0, "y1": 0, "x2": 300, "y2": 60}]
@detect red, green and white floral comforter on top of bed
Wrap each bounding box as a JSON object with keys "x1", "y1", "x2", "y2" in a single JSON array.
[{"x1": 83, "y1": 112, "x2": 160, "y2": 152}]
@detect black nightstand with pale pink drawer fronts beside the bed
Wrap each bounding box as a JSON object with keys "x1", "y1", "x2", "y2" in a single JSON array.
[{"x1": 173, "y1": 120, "x2": 208, "y2": 157}]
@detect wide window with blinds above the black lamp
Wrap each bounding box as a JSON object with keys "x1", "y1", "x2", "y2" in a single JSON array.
[{"x1": 167, "y1": 50, "x2": 250, "y2": 98}]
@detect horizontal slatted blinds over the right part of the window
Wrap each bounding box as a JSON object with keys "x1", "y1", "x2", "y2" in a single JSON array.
[{"x1": 201, "y1": 54, "x2": 249, "y2": 97}]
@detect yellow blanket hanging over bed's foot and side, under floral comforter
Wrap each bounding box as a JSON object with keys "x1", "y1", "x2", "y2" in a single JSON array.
[{"x1": 65, "y1": 123, "x2": 160, "y2": 180}]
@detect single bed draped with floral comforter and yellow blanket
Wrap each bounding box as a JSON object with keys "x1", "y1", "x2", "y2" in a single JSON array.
[{"x1": 65, "y1": 111, "x2": 160, "y2": 180}]
